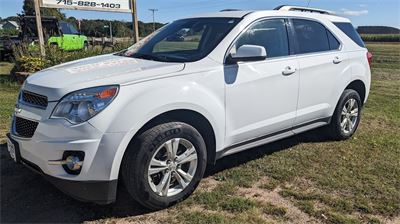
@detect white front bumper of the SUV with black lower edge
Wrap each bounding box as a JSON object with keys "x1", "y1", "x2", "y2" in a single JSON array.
[{"x1": 7, "y1": 107, "x2": 126, "y2": 204}]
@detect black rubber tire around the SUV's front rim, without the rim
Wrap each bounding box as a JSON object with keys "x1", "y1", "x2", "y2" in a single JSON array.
[{"x1": 121, "y1": 122, "x2": 207, "y2": 210}]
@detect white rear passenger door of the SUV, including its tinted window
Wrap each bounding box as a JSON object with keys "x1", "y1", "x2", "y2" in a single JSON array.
[{"x1": 291, "y1": 19, "x2": 351, "y2": 126}]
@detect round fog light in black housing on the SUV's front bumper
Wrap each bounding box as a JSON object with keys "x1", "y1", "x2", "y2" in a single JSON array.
[{"x1": 48, "y1": 151, "x2": 85, "y2": 175}]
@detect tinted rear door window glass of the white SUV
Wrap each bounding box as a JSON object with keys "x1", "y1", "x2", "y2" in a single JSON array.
[{"x1": 293, "y1": 19, "x2": 330, "y2": 54}]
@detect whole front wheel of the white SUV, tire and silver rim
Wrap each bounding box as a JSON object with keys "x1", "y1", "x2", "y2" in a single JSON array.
[{"x1": 121, "y1": 122, "x2": 207, "y2": 209}]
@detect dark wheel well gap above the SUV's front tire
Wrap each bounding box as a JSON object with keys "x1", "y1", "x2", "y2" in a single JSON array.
[{"x1": 132, "y1": 110, "x2": 216, "y2": 164}]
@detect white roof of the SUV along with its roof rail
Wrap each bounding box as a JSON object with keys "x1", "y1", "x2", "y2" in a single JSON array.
[{"x1": 188, "y1": 10, "x2": 350, "y2": 22}]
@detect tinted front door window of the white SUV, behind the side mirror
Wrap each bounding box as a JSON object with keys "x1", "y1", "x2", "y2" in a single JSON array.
[{"x1": 234, "y1": 19, "x2": 289, "y2": 58}]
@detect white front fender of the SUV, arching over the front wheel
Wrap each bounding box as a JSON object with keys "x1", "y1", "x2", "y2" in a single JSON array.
[{"x1": 90, "y1": 74, "x2": 225, "y2": 179}]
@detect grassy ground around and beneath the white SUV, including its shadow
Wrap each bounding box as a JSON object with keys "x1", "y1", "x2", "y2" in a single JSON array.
[{"x1": 0, "y1": 43, "x2": 400, "y2": 224}]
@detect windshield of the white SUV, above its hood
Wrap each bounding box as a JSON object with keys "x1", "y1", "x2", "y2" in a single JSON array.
[{"x1": 121, "y1": 18, "x2": 240, "y2": 62}]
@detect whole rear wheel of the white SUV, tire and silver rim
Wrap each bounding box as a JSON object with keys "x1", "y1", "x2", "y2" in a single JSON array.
[{"x1": 327, "y1": 89, "x2": 362, "y2": 140}]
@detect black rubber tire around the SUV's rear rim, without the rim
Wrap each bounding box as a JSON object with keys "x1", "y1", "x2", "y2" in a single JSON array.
[{"x1": 326, "y1": 89, "x2": 363, "y2": 140}]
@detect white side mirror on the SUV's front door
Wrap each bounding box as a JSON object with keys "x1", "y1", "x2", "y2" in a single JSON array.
[{"x1": 228, "y1": 45, "x2": 267, "y2": 63}]
